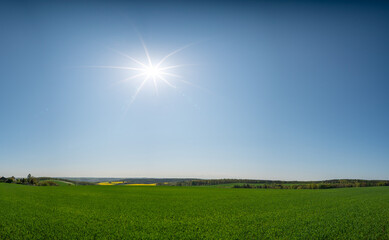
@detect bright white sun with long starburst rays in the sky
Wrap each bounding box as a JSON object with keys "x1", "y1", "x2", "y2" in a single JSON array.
[{"x1": 94, "y1": 38, "x2": 191, "y2": 104}]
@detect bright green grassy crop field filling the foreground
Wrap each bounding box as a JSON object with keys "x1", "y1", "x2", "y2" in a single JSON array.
[{"x1": 0, "y1": 184, "x2": 389, "y2": 239}]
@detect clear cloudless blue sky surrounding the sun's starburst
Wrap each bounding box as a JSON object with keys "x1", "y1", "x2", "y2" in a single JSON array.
[{"x1": 0, "y1": 1, "x2": 389, "y2": 180}]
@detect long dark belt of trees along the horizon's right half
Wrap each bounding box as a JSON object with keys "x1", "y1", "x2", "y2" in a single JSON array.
[{"x1": 169, "y1": 179, "x2": 389, "y2": 189}]
